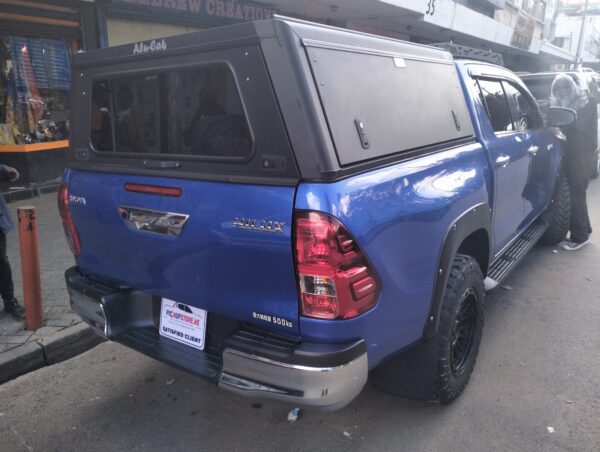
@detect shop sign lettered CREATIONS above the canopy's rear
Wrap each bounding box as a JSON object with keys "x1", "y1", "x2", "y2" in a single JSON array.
[{"x1": 113, "y1": 0, "x2": 277, "y2": 22}]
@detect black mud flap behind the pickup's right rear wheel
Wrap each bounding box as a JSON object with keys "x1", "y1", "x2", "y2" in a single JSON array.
[{"x1": 371, "y1": 337, "x2": 438, "y2": 400}]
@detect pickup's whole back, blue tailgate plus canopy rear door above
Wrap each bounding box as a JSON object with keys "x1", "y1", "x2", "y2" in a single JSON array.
[{"x1": 67, "y1": 33, "x2": 298, "y2": 335}]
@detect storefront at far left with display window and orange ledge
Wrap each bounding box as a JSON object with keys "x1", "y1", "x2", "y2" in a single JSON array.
[{"x1": 0, "y1": 0, "x2": 97, "y2": 185}]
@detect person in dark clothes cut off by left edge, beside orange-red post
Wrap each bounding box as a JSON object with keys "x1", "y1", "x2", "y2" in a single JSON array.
[{"x1": 0, "y1": 164, "x2": 25, "y2": 319}]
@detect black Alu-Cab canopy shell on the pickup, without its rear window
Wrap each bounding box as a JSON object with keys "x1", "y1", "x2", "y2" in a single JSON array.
[{"x1": 71, "y1": 16, "x2": 464, "y2": 184}]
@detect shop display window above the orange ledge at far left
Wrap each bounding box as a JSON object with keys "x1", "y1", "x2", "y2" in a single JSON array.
[{"x1": 0, "y1": 36, "x2": 71, "y2": 144}]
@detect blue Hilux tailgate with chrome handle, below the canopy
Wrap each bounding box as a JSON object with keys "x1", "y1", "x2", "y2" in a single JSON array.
[{"x1": 67, "y1": 170, "x2": 298, "y2": 334}]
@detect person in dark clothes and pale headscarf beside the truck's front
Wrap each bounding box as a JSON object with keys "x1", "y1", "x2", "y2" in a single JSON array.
[{"x1": 551, "y1": 74, "x2": 598, "y2": 251}]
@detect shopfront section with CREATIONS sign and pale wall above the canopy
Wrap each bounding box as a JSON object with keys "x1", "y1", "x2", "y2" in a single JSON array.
[{"x1": 97, "y1": 0, "x2": 277, "y2": 47}]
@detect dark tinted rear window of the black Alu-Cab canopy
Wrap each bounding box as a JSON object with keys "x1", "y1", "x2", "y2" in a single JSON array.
[{"x1": 90, "y1": 64, "x2": 251, "y2": 159}]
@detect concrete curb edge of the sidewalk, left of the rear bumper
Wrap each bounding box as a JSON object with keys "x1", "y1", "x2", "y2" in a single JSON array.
[{"x1": 0, "y1": 322, "x2": 103, "y2": 384}]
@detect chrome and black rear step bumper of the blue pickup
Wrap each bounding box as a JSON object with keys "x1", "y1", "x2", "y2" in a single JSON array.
[{"x1": 65, "y1": 267, "x2": 368, "y2": 410}]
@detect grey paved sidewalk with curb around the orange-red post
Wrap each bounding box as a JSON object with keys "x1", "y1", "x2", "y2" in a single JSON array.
[{"x1": 0, "y1": 193, "x2": 99, "y2": 384}]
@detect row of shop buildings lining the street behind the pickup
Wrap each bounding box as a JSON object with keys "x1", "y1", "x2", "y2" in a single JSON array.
[{"x1": 0, "y1": 0, "x2": 600, "y2": 187}]
